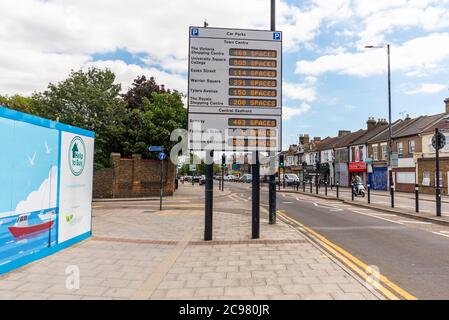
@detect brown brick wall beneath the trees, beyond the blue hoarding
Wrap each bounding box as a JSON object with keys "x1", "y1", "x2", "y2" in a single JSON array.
[{"x1": 93, "y1": 154, "x2": 175, "y2": 198}]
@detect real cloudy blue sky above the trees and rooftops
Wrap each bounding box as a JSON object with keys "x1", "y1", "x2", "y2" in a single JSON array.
[{"x1": 0, "y1": 0, "x2": 449, "y2": 147}]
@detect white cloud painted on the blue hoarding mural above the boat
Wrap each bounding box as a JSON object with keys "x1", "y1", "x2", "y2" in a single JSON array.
[{"x1": 15, "y1": 166, "x2": 58, "y2": 214}]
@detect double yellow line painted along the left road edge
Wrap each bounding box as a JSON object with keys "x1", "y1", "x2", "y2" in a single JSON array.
[{"x1": 278, "y1": 211, "x2": 417, "y2": 300}]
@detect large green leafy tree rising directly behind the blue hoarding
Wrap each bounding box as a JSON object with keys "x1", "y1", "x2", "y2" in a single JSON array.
[{"x1": 31, "y1": 68, "x2": 128, "y2": 168}]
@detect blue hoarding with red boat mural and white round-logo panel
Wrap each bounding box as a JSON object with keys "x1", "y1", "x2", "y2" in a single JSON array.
[{"x1": 0, "y1": 106, "x2": 95, "y2": 274}]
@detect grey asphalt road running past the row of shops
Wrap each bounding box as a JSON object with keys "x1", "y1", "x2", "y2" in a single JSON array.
[{"x1": 222, "y1": 183, "x2": 449, "y2": 299}]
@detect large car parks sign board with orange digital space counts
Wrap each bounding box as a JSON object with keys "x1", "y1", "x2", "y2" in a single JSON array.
[{"x1": 188, "y1": 27, "x2": 282, "y2": 151}]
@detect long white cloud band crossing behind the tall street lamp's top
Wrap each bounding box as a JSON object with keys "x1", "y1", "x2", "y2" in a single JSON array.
[{"x1": 296, "y1": 33, "x2": 449, "y2": 76}]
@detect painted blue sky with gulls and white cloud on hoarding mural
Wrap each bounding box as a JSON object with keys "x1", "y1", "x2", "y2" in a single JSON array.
[{"x1": 0, "y1": 118, "x2": 58, "y2": 216}]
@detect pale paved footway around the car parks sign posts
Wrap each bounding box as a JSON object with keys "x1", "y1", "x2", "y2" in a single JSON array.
[{"x1": 0, "y1": 184, "x2": 382, "y2": 300}]
